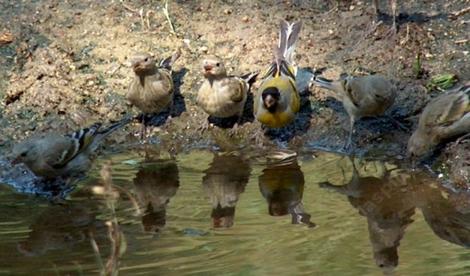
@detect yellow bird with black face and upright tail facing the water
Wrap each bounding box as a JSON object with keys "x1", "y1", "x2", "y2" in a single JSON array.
[{"x1": 253, "y1": 20, "x2": 302, "y2": 128}]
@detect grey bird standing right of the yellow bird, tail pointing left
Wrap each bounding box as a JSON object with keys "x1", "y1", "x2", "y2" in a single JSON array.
[{"x1": 311, "y1": 75, "x2": 396, "y2": 148}]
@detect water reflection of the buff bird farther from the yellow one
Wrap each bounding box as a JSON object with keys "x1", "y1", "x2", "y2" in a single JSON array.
[{"x1": 134, "y1": 161, "x2": 179, "y2": 232}]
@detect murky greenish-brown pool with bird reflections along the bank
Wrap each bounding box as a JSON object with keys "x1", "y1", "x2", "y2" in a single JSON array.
[{"x1": 0, "y1": 151, "x2": 470, "y2": 275}]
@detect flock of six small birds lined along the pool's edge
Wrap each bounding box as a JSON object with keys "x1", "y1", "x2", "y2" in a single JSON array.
[{"x1": 7, "y1": 18, "x2": 470, "y2": 183}]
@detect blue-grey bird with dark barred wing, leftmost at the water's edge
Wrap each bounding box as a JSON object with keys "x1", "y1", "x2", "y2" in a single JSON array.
[{"x1": 10, "y1": 118, "x2": 132, "y2": 180}]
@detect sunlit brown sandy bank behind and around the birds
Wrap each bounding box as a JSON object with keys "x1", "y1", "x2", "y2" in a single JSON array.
[{"x1": 0, "y1": 0, "x2": 470, "y2": 188}]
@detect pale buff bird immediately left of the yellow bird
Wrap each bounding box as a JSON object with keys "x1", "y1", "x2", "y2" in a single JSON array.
[{"x1": 197, "y1": 56, "x2": 258, "y2": 131}]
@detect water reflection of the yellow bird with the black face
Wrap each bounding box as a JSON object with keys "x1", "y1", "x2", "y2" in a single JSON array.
[{"x1": 258, "y1": 159, "x2": 315, "y2": 227}]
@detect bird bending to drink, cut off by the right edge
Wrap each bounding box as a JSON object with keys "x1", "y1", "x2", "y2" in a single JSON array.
[{"x1": 407, "y1": 82, "x2": 470, "y2": 160}]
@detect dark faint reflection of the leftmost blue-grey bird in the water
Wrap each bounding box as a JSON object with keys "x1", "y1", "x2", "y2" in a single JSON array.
[{"x1": 17, "y1": 202, "x2": 107, "y2": 256}]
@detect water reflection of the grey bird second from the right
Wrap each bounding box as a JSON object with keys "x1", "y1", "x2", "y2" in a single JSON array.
[{"x1": 320, "y1": 160, "x2": 415, "y2": 272}]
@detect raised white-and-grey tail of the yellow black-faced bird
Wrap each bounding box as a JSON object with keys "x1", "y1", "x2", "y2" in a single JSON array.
[{"x1": 275, "y1": 20, "x2": 302, "y2": 67}]
